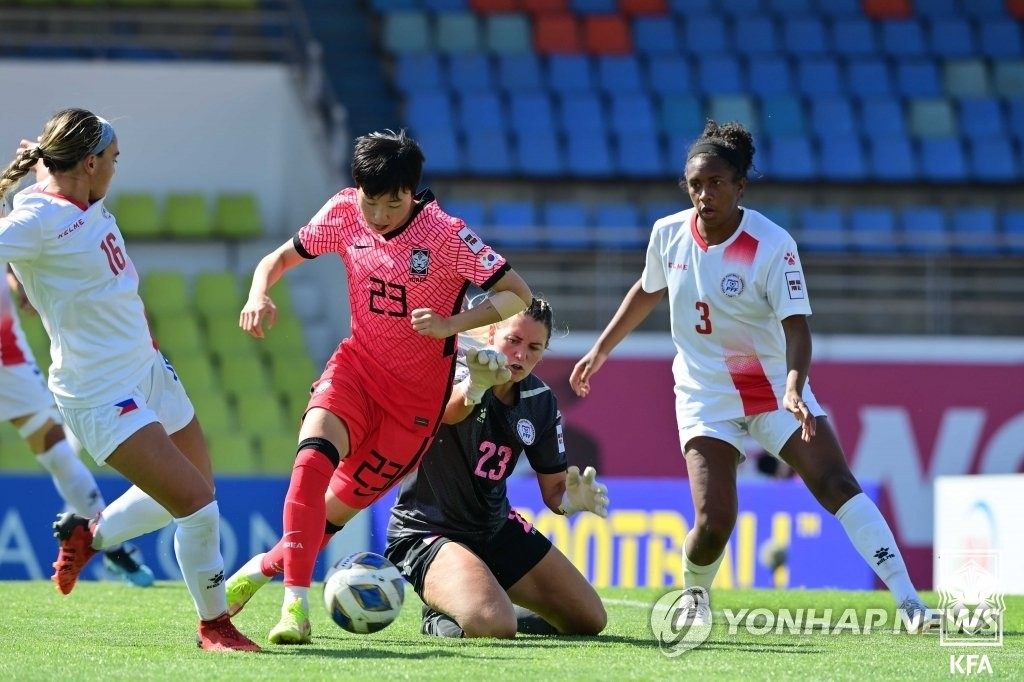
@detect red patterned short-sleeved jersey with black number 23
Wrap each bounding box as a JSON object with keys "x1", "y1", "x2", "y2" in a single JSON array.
[{"x1": 293, "y1": 187, "x2": 509, "y2": 432}]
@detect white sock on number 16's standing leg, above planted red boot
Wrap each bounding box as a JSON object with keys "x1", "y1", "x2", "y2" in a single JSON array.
[{"x1": 174, "y1": 500, "x2": 227, "y2": 621}]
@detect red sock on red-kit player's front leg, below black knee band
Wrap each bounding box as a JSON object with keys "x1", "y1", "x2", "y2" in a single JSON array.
[{"x1": 274, "y1": 449, "x2": 334, "y2": 587}]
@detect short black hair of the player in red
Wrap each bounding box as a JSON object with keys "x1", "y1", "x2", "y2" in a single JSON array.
[{"x1": 352, "y1": 129, "x2": 424, "y2": 197}]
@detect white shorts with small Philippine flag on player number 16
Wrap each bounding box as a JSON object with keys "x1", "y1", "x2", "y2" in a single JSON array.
[{"x1": 60, "y1": 355, "x2": 196, "y2": 465}]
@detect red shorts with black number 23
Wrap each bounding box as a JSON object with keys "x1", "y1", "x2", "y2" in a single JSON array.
[{"x1": 306, "y1": 350, "x2": 434, "y2": 509}]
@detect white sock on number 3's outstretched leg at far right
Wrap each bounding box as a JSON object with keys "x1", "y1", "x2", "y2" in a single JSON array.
[{"x1": 836, "y1": 493, "x2": 920, "y2": 604}]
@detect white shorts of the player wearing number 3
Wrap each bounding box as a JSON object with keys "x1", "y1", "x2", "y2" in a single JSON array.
[{"x1": 679, "y1": 387, "x2": 825, "y2": 462}]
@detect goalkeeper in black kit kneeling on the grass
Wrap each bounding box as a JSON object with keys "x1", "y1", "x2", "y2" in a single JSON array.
[{"x1": 385, "y1": 298, "x2": 608, "y2": 638}]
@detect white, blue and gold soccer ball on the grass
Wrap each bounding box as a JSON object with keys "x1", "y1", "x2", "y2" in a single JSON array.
[{"x1": 324, "y1": 552, "x2": 406, "y2": 634}]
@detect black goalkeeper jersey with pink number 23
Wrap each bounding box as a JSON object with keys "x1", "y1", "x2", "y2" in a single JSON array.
[{"x1": 387, "y1": 367, "x2": 566, "y2": 541}]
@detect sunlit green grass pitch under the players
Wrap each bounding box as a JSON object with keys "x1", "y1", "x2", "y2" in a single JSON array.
[{"x1": 0, "y1": 582, "x2": 1024, "y2": 682}]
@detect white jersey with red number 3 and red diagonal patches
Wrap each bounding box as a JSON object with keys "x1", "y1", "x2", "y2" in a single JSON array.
[{"x1": 640, "y1": 204, "x2": 811, "y2": 423}]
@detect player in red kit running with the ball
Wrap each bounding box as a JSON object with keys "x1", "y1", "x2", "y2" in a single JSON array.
[{"x1": 227, "y1": 130, "x2": 532, "y2": 644}]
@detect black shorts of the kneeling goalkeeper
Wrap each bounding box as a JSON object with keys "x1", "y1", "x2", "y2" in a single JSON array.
[{"x1": 384, "y1": 509, "x2": 551, "y2": 599}]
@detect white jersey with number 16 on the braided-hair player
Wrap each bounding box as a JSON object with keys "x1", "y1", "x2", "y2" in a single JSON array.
[{"x1": 0, "y1": 184, "x2": 158, "y2": 408}]
